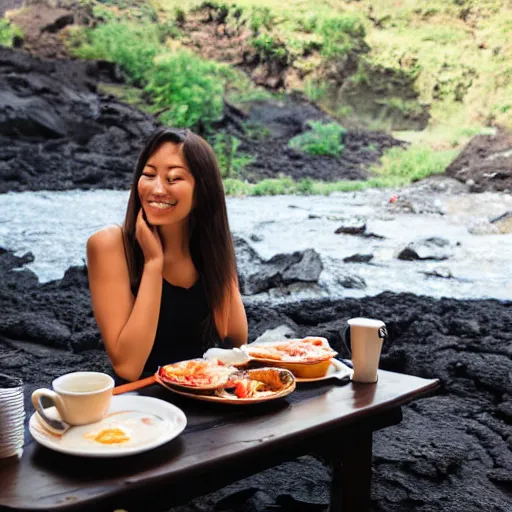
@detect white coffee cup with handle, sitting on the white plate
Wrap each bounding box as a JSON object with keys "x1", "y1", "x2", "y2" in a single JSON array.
[{"x1": 32, "y1": 372, "x2": 114, "y2": 431}]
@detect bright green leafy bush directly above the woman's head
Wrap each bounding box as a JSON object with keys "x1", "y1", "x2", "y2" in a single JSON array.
[{"x1": 145, "y1": 50, "x2": 224, "y2": 129}]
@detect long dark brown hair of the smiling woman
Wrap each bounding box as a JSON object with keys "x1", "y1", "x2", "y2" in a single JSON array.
[{"x1": 123, "y1": 128, "x2": 237, "y2": 337}]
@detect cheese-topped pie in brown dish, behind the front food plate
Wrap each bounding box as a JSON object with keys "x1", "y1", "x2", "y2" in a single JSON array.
[{"x1": 242, "y1": 336, "x2": 337, "y2": 379}]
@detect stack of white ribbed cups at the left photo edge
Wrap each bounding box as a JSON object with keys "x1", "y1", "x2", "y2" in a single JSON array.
[{"x1": 0, "y1": 374, "x2": 25, "y2": 459}]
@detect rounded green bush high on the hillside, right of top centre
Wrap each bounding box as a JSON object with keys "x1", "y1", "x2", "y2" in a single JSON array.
[{"x1": 316, "y1": 14, "x2": 365, "y2": 59}]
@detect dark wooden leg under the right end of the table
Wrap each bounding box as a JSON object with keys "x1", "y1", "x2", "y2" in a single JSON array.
[{"x1": 329, "y1": 429, "x2": 372, "y2": 512}]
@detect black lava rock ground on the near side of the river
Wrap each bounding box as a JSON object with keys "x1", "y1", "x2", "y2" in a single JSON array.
[{"x1": 0, "y1": 250, "x2": 512, "y2": 512}]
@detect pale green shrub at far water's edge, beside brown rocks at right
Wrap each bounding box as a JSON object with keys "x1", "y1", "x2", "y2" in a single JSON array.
[{"x1": 373, "y1": 145, "x2": 457, "y2": 185}]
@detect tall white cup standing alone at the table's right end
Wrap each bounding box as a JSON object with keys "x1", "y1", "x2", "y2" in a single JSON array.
[{"x1": 347, "y1": 317, "x2": 388, "y2": 383}]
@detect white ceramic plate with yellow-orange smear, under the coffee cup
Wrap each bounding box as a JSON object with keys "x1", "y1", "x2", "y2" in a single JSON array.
[{"x1": 29, "y1": 395, "x2": 187, "y2": 457}]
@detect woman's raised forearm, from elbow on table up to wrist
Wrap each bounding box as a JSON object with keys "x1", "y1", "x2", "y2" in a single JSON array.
[{"x1": 111, "y1": 262, "x2": 162, "y2": 380}]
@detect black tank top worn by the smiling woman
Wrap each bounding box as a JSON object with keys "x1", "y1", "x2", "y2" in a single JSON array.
[{"x1": 116, "y1": 278, "x2": 220, "y2": 385}]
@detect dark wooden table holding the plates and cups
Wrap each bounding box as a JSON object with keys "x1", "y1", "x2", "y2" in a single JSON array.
[{"x1": 0, "y1": 371, "x2": 439, "y2": 512}]
